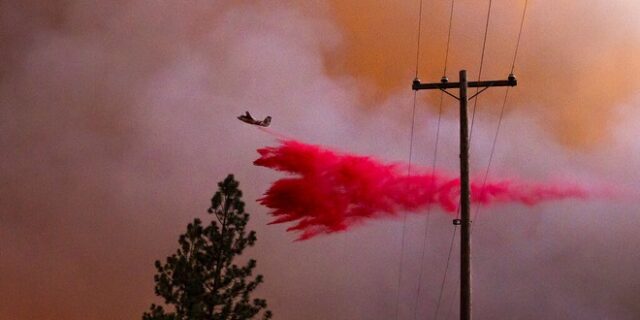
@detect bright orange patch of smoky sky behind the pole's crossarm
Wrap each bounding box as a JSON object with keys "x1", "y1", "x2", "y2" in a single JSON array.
[{"x1": 324, "y1": 0, "x2": 640, "y2": 148}]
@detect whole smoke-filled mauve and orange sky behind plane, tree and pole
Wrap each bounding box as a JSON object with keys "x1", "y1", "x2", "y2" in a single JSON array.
[{"x1": 0, "y1": 0, "x2": 640, "y2": 320}]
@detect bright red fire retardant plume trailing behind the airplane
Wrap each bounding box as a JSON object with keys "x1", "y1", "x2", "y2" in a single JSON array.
[{"x1": 254, "y1": 140, "x2": 588, "y2": 240}]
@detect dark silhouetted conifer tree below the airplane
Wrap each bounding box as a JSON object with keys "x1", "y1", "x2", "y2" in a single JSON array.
[{"x1": 142, "y1": 175, "x2": 272, "y2": 320}]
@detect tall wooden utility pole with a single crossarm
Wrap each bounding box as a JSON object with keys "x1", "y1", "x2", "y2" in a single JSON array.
[{"x1": 411, "y1": 70, "x2": 518, "y2": 320}]
